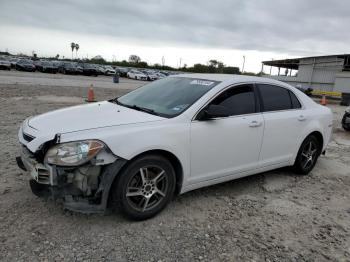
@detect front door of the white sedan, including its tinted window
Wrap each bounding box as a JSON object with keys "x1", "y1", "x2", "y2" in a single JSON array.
[{"x1": 190, "y1": 84, "x2": 264, "y2": 183}]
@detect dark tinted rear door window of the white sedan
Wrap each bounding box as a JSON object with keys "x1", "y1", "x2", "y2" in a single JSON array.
[{"x1": 258, "y1": 84, "x2": 293, "y2": 112}]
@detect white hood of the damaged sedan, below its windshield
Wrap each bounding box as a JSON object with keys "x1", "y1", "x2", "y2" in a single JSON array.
[{"x1": 28, "y1": 101, "x2": 164, "y2": 134}]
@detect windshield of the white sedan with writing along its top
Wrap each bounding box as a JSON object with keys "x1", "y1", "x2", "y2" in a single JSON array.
[{"x1": 114, "y1": 77, "x2": 219, "y2": 118}]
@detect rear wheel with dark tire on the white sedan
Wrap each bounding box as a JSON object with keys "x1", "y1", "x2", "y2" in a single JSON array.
[{"x1": 293, "y1": 135, "x2": 322, "y2": 175}]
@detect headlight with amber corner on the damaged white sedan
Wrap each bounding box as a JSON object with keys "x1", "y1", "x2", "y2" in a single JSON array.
[{"x1": 45, "y1": 140, "x2": 104, "y2": 166}]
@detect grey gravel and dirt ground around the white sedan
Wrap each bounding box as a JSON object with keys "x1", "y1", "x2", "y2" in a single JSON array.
[{"x1": 0, "y1": 71, "x2": 350, "y2": 261}]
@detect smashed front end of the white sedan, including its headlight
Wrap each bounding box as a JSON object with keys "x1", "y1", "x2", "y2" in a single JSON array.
[{"x1": 16, "y1": 136, "x2": 126, "y2": 213}]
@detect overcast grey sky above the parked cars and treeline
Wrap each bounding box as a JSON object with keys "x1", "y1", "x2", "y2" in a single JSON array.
[{"x1": 0, "y1": 0, "x2": 350, "y2": 72}]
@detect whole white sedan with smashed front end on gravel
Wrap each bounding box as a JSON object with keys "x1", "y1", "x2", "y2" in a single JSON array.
[{"x1": 17, "y1": 74, "x2": 332, "y2": 220}]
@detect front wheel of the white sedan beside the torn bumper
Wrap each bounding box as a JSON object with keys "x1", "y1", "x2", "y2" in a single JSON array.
[{"x1": 113, "y1": 155, "x2": 176, "y2": 220}]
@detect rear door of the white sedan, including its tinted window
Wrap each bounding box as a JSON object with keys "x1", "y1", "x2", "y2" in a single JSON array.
[{"x1": 257, "y1": 84, "x2": 308, "y2": 167}]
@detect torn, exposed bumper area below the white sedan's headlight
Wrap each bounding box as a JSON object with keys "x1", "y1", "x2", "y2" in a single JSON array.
[{"x1": 16, "y1": 138, "x2": 126, "y2": 213}]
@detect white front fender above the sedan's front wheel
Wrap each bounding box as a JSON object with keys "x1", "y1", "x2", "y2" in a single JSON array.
[{"x1": 61, "y1": 120, "x2": 190, "y2": 184}]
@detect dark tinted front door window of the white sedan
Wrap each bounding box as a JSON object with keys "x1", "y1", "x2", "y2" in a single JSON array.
[{"x1": 211, "y1": 85, "x2": 256, "y2": 116}]
